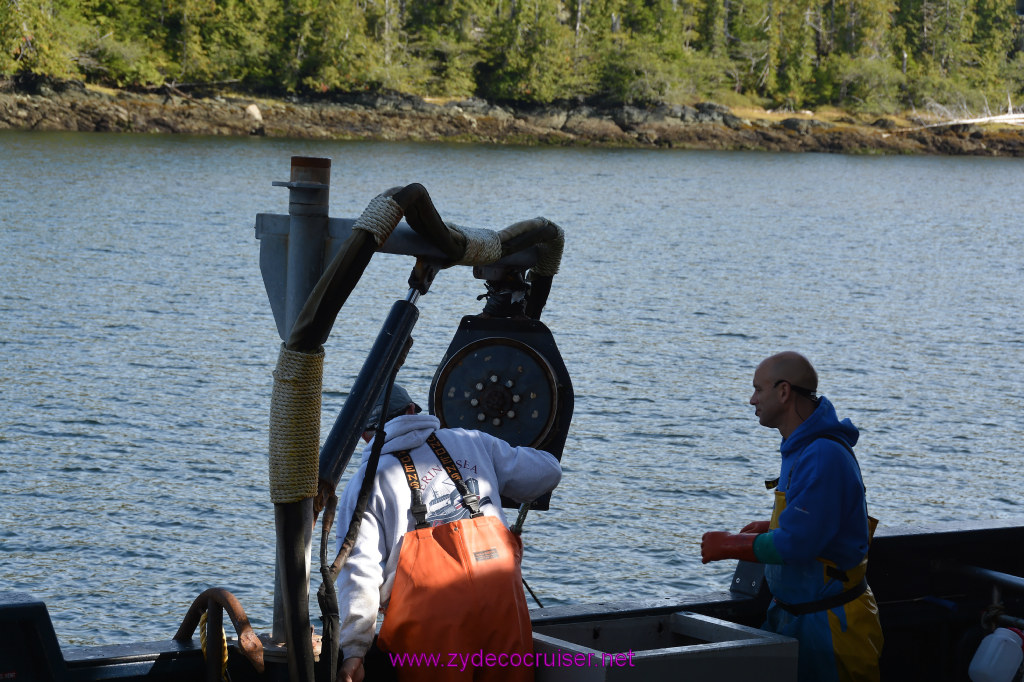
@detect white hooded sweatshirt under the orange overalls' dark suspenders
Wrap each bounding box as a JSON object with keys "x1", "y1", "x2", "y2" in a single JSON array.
[{"x1": 336, "y1": 414, "x2": 562, "y2": 658}]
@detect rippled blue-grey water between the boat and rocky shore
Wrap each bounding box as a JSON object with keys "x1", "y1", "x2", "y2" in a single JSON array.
[{"x1": 0, "y1": 132, "x2": 1024, "y2": 644}]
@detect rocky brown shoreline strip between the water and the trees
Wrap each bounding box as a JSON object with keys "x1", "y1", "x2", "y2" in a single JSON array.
[{"x1": 0, "y1": 80, "x2": 1024, "y2": 157}]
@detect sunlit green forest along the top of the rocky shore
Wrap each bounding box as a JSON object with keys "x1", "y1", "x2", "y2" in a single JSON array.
[{"x1": 6, "y1": 0, "x2": 1024, "y2": 118}]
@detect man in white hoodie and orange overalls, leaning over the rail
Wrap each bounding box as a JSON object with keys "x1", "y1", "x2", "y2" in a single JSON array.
[{"x1": 338, "y1": 384, "x2": 561, "y2": 682}]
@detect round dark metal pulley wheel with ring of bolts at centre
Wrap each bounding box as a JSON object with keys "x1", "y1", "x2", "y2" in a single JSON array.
[{"x1": 432, "y1": 337, "x2": 558, "y2": 447}]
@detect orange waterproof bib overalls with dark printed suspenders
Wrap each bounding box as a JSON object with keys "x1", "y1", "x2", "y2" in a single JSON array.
[{"x1": 377, "y1": 434, "x2": 534, "y2": 682}]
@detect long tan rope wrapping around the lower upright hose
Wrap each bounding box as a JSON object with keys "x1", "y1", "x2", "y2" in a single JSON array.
[{"x1": 270, "y1": 344, "x2": 324, "y2": 504}]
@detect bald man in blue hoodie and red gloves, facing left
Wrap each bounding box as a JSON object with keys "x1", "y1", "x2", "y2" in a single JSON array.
[{"x1": 700, "y1": 351, "x2": 883, "y2": 682}]
